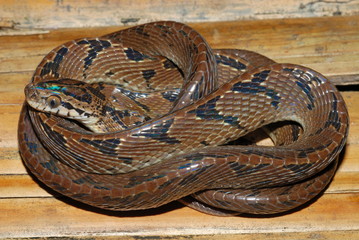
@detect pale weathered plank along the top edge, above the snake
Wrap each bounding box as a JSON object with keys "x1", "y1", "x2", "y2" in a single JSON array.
[{"x1": 0, "y1": 0, "x2": 359, "y2": 29}]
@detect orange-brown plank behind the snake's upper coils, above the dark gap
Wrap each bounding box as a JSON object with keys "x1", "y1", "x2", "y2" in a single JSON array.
[{"x1": 0, "y1": 16, "x2": 359, "y2": 84}]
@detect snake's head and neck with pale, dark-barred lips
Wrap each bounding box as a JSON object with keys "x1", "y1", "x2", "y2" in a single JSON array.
[{"x1": 25, "y1": 79, "x2": 153, "y2": 133}]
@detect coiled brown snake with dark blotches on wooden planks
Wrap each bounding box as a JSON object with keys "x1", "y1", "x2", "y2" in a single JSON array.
[{"x1": 18, "y1": 21, "x2": 349, "y2": 216}]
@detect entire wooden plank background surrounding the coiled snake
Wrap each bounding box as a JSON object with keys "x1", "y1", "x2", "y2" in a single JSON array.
[{"x1": 0, "y1": 0, "x2": 359, "y2": 239}]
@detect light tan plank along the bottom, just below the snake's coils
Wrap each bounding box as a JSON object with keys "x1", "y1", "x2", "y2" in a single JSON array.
[{"x1": 0, "y1": 193, "x2": 359, "y2": 237}]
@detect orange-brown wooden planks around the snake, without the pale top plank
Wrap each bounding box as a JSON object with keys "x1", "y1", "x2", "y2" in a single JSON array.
[{"x1": 0, "y1": 16, "x2": 359, "y2": 239}]
